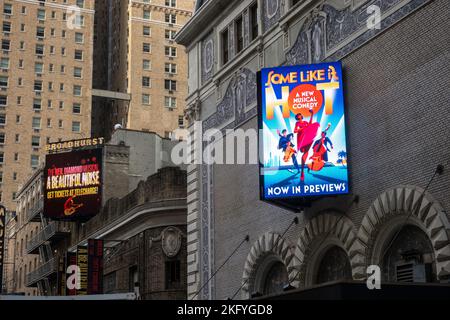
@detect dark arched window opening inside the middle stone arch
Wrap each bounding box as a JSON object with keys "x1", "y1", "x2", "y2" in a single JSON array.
[{"x1": 315, "y1": 246, "x2": 352, "y2": 284}]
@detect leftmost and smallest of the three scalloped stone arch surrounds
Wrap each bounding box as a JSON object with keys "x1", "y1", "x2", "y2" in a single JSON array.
[{"x1": 242, "y1": 232, "x2": 296, "y2": 299}]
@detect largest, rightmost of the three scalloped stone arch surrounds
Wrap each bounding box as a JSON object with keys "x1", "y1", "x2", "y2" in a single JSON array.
[{"x1": 350, "y1": 185, "x2": 450, "y2": 280}]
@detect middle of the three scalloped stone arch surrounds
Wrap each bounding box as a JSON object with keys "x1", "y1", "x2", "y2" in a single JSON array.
[{"x1": 293, "y1": 213, "x2": 356, "y2": 287}]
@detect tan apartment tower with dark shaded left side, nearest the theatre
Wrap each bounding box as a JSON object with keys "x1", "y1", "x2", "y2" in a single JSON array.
[{"x1": 93, "y1": 0, "x2": 195, "y2": 138}]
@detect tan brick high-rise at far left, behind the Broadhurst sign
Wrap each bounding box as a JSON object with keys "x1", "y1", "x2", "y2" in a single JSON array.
[{"x1": 0, "y1": 0, "x2": 94, "y2": 211}]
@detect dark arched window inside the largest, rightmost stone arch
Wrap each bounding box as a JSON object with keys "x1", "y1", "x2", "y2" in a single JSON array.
[{"x1": 381, "y1": 225, "x2": 436, "y2": 282}]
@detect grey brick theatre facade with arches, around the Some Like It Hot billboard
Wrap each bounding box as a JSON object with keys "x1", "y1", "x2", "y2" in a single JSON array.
[{"x1": 177, "y1": 0, "x2": 450, "y2": 299}]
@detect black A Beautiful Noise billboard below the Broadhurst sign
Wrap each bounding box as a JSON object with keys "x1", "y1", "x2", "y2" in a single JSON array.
[{"x1": 44, "y1": 148, "x2": 102, "y2": 221}]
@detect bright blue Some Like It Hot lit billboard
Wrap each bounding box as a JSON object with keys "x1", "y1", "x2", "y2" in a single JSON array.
[{"x1": 258, "y1": 62, "x2": 349, "y2": 200}]
